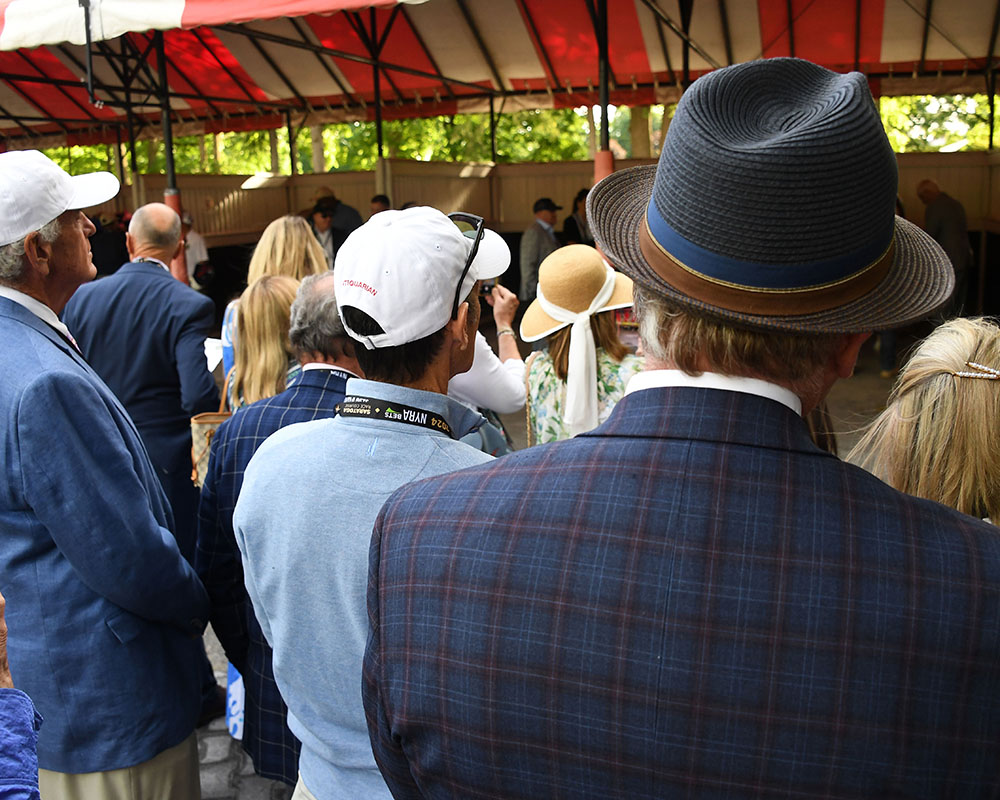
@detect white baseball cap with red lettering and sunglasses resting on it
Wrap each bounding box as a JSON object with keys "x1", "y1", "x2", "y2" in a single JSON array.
[{"x1": 333, "y1": 206, "x2": 510, "y2": 350}]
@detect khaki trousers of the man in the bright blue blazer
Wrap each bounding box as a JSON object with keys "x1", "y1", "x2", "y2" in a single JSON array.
[{"x1": 38, "y1": 733, "x2": 201, "y2": 800}]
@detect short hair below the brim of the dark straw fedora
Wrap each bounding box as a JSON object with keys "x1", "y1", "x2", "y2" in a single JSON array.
[{"x1": 633, "y1": 284, "x2": 845, "y2": 397}]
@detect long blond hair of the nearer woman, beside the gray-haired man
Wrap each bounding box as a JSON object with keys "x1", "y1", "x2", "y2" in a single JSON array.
[{"x1": 231, "y1": 275, "x2": 299, "y2": 403}]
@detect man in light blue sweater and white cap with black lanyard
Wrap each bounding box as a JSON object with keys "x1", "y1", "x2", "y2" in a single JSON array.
[{"x1": 234, "y1": 208, "x2": 510, "y2": 800}]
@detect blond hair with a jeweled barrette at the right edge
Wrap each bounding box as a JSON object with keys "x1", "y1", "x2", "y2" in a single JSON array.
[{"x1": 848, "y1": 317, "x2": 1000, "y2": 522}]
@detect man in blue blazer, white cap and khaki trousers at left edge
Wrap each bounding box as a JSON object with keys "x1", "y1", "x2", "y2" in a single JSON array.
[{"x1": 0, "y1": 151, "x2": 208, "y2": 800}]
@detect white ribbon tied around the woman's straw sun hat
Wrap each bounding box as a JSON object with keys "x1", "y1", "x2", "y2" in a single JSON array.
[{"x1": 536, "y1": 265, "x2": 615, "y2": 436}]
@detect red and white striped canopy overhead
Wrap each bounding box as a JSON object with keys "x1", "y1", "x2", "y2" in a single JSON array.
[{"x1": 0, "y1": 0, "x2": 1000, "y2": 147}]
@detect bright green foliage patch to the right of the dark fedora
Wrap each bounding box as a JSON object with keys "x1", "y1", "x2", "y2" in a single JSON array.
[{"x1": 879, "y1": 94, "x2": 989, "y2": 153}]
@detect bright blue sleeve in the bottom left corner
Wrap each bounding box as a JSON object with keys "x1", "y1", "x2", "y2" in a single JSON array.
[{"x1": 0, "y1": 689, "x2": 42, "y2": 800}]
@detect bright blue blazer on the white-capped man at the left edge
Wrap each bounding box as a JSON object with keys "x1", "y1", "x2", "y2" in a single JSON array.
[{"x1": 0, "y1": 297, "x2": 208, "y2": 772}]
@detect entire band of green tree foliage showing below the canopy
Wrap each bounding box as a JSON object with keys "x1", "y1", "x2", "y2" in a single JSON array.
[{"x1": 44, "y1": 94, "x2": 989, "y2": 175}]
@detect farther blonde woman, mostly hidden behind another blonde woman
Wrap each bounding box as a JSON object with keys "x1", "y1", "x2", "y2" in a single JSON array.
[{"x1": 222, "y1": 214, "x2": 327, "y2": 375}]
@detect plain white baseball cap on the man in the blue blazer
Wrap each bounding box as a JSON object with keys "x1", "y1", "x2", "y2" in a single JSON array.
[{"x1": 0, "y1": 150, "x2": 121, "y2": 247}]
